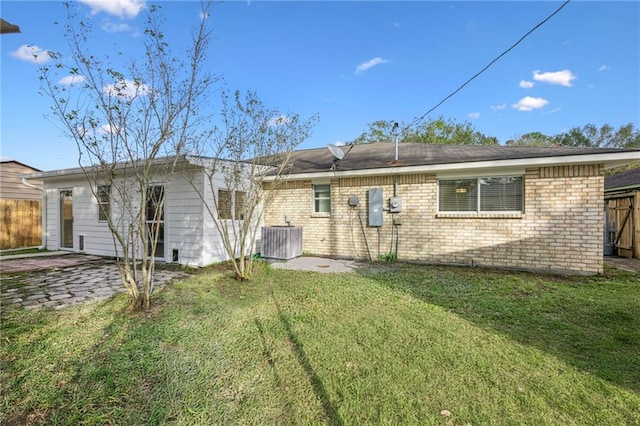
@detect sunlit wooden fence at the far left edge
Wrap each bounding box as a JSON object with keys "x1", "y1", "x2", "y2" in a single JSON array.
[{"x1": 0, "y1": 200, "x2": 42, "y2": 250}]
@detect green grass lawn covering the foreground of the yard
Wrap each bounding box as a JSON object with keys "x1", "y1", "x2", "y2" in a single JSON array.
[{"x1": 0, "y1": 264, "x2": 640, "y2": 425}]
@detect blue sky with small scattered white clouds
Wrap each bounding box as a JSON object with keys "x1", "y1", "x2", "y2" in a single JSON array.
[{"x1": 0, "y1": 0, "x2": 640, "y2": 170}]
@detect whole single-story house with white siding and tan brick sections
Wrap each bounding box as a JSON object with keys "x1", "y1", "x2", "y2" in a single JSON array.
[{"x1": 29, "y1": 143, "x2": 640, "y2": 273}]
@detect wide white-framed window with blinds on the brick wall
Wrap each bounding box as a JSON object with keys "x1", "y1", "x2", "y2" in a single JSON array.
[{"x1": 438, "y1": 176, "x2": 524, "y2": 213}]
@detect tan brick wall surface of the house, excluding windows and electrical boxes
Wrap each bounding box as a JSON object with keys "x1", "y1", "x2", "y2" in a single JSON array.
[{"x1": 265, "y1": 165, "x2": 604, "y2": 273}]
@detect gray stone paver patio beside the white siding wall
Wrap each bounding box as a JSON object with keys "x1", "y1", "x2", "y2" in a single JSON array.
[{"x1": 0, "y1": 255, "x2": 188, "y2": 311}]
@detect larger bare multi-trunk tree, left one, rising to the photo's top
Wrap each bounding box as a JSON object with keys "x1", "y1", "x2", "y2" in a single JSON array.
[{"x1": 36, "y1": 3, "x2": 216, "y2": 309}]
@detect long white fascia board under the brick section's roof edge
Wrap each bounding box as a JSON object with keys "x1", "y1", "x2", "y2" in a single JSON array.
[{"x1": 265, "y1": 151, "x2": 640, "y2": 181}]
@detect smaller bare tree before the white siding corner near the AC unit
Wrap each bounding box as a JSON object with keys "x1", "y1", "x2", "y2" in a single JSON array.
[{"x1": 190, "y1": 91, "x2": 316, "y2": 281}]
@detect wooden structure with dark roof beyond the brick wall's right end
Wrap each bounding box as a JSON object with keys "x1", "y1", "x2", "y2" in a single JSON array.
[{"x1": 604, "y1": 168, "x2": 640, "y2": 259}]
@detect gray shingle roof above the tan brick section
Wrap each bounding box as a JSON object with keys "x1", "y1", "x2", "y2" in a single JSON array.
[{"x1": 278, "y1": 142, "x2": 640, "y2": 174}]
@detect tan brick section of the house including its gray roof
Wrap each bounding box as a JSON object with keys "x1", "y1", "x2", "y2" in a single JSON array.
[{"x1": 265, "y1": 143, "x2": 640, "y2": 273}]
